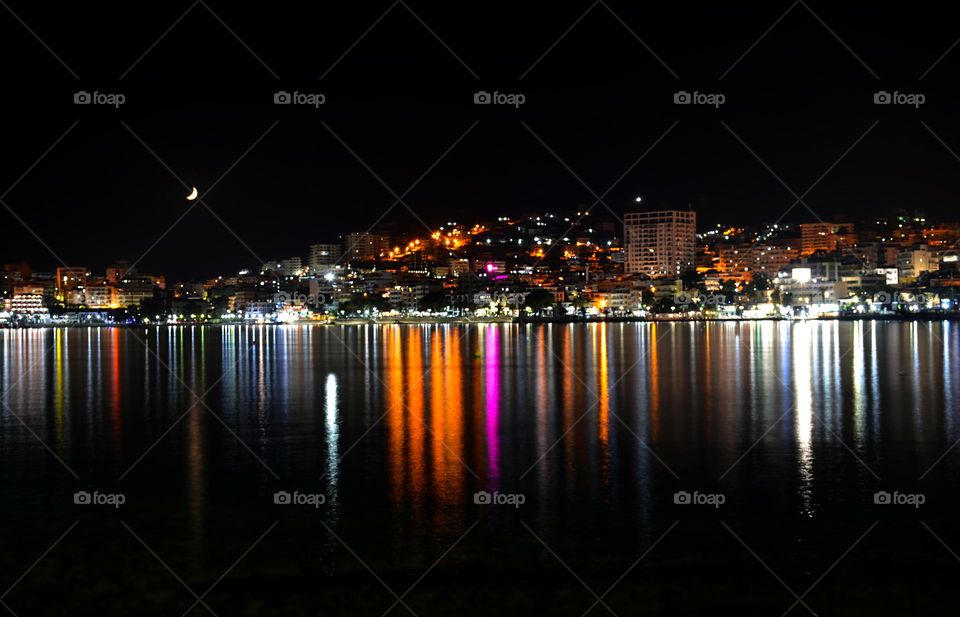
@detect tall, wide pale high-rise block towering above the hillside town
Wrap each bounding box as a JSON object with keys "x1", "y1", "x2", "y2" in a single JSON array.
[{"x1": 623, "y1": 210, "x2": 697, "y2": 277}]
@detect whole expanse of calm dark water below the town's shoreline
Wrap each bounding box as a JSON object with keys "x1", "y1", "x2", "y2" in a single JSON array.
[{"x1": 0, "y1": 321, "x2": 960, "y2": 617}]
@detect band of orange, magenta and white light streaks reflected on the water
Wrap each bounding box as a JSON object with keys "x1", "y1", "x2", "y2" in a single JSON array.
[{"x1": 0, "y1": 321, "x2": 960, "y2": 524}]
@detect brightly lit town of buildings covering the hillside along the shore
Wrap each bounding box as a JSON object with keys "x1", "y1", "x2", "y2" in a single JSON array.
[{"x1": 0, "y1": 209, "x2": 960, "y2": 327}]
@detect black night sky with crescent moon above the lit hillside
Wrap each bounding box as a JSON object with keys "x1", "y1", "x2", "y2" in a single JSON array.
[{"x1": 0, "y1": 0, "x2": 960, "y2": 278}]
